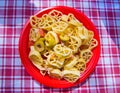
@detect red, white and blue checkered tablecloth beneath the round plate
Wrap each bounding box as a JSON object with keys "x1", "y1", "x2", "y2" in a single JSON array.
[{"x1": 0, "y1": 0, "x2": 120, "y2": 93}]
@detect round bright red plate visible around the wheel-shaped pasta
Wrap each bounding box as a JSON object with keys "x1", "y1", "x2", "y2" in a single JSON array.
[{"x1": 19, "y1": 6, "x2": 100, "y2": 88}]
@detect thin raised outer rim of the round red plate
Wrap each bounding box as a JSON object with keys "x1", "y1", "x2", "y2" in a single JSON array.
[{"x1": 19, "y1": 6, "x2": 101, "y2": 88}]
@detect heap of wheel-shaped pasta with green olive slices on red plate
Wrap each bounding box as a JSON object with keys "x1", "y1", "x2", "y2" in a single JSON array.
[{"x1": 29, "y1": 10, "x2": 98, "y2": 83}]
